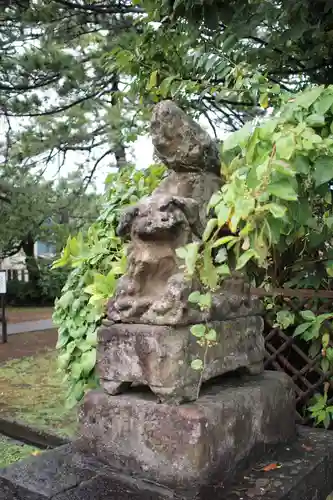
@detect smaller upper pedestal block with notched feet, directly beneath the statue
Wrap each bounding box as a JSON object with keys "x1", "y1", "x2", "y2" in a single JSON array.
[{"x1": 97, "y1": 316, "x2": 264, "y2": 404}]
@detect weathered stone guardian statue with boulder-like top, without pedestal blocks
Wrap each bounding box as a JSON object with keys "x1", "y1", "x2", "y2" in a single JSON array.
[{"x1": 108, "y1": 101, "x2": 228, "y2": 325}]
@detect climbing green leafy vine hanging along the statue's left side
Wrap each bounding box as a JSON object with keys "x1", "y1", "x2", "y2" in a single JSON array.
[{"x1": 53, "y1": 165, "x2": 164, "y2": 405}]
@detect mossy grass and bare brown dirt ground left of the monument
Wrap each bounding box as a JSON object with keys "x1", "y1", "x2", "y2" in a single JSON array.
[{"x1": 0, "y1": 328, "x2": 77, "y2": 468}]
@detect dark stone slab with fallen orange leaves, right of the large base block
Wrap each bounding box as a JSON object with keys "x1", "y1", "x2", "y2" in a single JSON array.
[{"x1": 224, "y1": 427, "x2": 333, "y2": 500}]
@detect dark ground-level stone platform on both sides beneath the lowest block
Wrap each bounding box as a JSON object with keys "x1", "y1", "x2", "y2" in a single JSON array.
[{"x1": 0, "y1": 428, "x2": 333, "y2": 500}]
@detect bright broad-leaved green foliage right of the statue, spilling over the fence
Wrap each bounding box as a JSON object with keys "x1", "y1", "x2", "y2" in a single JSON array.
[{"x1": 178, "y1": 86, "x2": 333, "y2": 423}]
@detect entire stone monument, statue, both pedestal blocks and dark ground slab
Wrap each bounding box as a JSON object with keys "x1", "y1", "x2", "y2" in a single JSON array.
[{"x1": 0, "y1": 101, "x2": 333, "y2": 500}]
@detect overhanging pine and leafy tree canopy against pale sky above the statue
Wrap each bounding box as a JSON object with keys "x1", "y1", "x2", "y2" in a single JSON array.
[{"x1": 0, "y1": 0, "x2": 333, "y2": 189}]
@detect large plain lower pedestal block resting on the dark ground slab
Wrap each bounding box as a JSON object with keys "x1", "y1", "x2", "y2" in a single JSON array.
[{"x1": 79, "y1": 372, "x2": 295, "y2": 499}]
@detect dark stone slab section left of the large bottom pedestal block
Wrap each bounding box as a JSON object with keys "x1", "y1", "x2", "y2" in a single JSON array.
[{"x1": 0, "y1": 445, "x2": 174, "y2": 500}]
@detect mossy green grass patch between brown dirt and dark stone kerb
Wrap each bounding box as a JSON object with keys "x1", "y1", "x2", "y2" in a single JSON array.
[{"x1": 0, "y1": 351, "x2": 77, "y2": 436}]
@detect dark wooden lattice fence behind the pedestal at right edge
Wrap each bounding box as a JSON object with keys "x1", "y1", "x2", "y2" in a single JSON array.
[{"x1": 252, "y1": 289, "x2": 333, "y2": 425}]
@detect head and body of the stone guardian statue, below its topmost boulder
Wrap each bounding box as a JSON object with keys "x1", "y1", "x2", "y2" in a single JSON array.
[{"x1": 108, "y1": 177, "x2": 223, "y2": 325}]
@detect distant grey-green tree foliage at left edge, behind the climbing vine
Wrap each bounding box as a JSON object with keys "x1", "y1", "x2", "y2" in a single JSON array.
[{"x1": 0, "y1": 170, "x2": 99, "y2": 257}]
